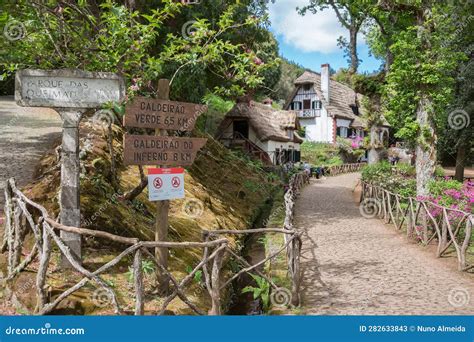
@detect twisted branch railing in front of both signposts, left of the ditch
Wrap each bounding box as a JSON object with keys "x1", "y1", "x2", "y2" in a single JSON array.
[{"x1": 1, "y1": 179, "x2": 228, "y2": 315}]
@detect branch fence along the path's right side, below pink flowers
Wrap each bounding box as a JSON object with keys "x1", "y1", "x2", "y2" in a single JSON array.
[{"x1": 361, "y1": 182, "x2": 474, "y2": 271}]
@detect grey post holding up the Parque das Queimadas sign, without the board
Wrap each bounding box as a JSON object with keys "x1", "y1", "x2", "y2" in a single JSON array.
[{"x1": 57, "y1": 109, "x2": 86, "y2": 268}]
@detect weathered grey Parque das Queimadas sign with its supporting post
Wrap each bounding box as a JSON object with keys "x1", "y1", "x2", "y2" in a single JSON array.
[{"x1": 15, "y1": 69, "x2": 125, "y2": 267}]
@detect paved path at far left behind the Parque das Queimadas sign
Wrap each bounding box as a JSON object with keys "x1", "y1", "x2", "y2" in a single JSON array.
[{"x1": 0, "y1": 97, "x2": 61, "y2": 211}]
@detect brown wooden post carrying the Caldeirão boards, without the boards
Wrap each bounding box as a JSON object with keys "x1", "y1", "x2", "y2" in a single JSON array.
[{"x1": 155, "y1": 79, "x2": 170, "y2": 295}]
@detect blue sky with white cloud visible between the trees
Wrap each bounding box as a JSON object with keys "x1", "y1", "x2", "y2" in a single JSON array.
[{"x1": 270, "y1": 0, "x2": 381, "y2": 72}]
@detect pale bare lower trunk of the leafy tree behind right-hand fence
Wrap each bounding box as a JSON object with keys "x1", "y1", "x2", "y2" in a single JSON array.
[{"x1": 416, "y1": 95, "x2": 437, "y2": 196}]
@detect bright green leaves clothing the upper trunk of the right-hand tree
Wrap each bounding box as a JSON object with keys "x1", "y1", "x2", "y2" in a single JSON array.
[{"x1": 384, "y1": 3, "x2": 466, "y2": 144}]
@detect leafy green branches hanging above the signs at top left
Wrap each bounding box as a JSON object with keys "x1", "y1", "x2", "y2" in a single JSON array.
[{"x1": 0, "y1": 0, "x2": 279, "y2": 102}]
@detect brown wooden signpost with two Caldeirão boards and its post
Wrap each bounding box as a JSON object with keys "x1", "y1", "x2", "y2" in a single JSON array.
[{"x1": 124, "y1": 79, "x2": 207, "y2": 294}]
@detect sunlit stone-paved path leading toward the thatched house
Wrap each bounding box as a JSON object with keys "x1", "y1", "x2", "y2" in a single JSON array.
[{"x1": 296, "y1": 174, "x2": 474, "y2": 315}]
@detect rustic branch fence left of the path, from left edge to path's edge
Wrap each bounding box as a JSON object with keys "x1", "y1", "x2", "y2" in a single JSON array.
[{"x1": 0, "y1": 173, "x2": 309, "y2": 315}]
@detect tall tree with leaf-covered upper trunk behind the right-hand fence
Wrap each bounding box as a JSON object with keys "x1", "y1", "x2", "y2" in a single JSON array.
[{"x1": 379, "y1": 0, "x2": 466, "y2": 196}]
